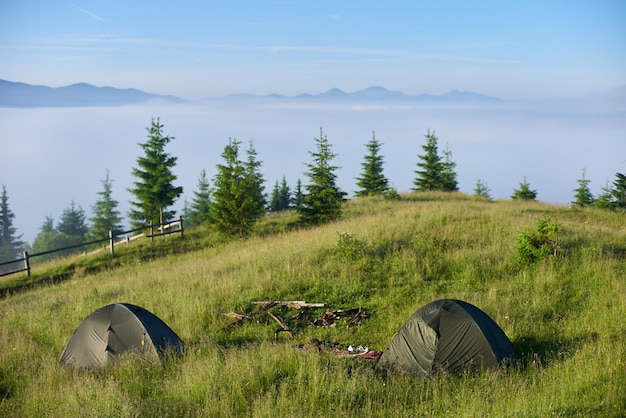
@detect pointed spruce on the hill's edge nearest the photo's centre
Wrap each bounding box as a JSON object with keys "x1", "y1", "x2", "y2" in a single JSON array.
[{"x1": 298, "y1": 128, "x2": 346, "y2": 225}]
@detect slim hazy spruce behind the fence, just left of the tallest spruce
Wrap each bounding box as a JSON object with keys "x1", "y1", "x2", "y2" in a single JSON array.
[{"x1": 88, "y1": 170, "x2": 122, "y2": 241}]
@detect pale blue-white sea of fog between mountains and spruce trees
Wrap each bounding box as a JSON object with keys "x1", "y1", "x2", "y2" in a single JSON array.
[{"x1": 0, "y1": 101, "x2": 626, "y2": 244}]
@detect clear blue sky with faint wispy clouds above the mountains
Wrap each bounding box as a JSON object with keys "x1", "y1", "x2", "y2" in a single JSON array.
[{"x1": 0, "y1": 0, "x2": 626, "y2": 99}]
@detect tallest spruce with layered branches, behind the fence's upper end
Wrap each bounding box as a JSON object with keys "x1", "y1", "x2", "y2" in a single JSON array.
[{"x1": 129, "y1": 118, "x2": 183, "y2": 228}]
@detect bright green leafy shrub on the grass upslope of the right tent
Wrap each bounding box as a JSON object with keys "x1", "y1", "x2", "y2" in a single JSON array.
[{"x1": 517, "y1": 215, "x2": 563, "y2": 263}]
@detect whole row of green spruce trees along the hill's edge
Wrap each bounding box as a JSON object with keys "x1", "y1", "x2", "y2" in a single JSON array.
[{"x1": 0, "y1": 118, "x2": 626, "y2": 268}]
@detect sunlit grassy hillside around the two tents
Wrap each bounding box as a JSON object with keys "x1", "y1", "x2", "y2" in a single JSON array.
[{"x1": 0, "y1": 194, "x2": 626, "y2": 417}]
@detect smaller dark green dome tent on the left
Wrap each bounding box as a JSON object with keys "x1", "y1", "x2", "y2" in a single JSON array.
[{"x1": 59, "y1": 303, "x2": 182, "y2": 368}]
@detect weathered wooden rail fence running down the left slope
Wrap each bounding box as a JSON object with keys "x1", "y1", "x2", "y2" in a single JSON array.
[{"x1": 0, "y1": 216, "x2": 185, "y2": 277}]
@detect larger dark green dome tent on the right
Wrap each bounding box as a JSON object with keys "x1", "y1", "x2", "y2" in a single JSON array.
[{"x1": 376, "y1": 299, "x2": 520, "y2": 376}]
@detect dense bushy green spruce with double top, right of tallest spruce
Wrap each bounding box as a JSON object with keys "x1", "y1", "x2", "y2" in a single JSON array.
[{"x1": 209, "y1": 139, "x2": 267, "y2": 237}]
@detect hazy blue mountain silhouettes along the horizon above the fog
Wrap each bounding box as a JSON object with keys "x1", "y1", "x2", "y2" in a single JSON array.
[{"x1": 0, "y1": 79, "x2": 626, "y2": 107}]
